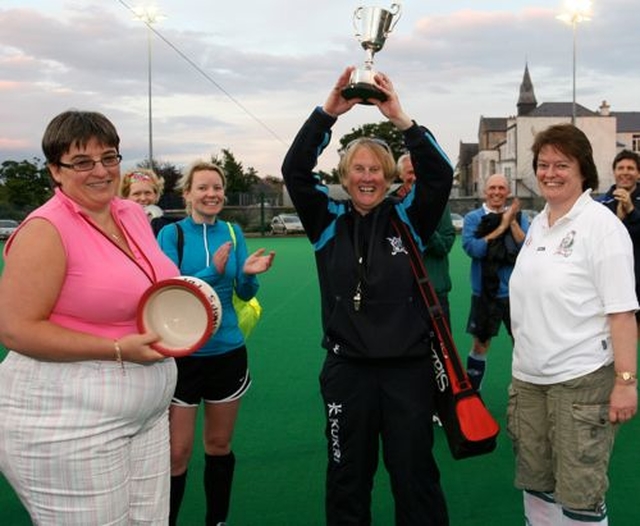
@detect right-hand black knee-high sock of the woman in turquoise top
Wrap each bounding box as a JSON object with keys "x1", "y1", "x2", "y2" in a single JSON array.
[{"x1": 204, "y1": 451, "x2": 236, "y2": 526}]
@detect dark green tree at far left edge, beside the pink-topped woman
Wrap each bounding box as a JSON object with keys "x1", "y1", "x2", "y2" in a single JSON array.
[{"x1": 0, "y1": 157, "x2": 52, "y2": 211}]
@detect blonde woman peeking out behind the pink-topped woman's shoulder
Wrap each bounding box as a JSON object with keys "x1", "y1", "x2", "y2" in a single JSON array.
[{"x1": 120, "y1": 168, "x2": 173, "y2": 235}]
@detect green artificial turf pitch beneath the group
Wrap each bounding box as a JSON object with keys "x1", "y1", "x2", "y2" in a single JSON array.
[{"x1": 0, "y1": 237, "x2": 640, "y2": 526}]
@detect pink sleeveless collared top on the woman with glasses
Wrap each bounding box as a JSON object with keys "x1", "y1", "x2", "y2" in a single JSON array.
[{"x1": 5, "y1": 189, "x2": 179, "y2": 338}]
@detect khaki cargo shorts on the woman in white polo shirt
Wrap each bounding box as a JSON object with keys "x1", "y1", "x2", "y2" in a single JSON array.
[{"x1": 507, "y1": 365, "x2": 615, "y2": 510}]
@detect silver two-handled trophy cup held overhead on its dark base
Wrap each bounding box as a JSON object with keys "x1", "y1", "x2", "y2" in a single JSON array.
[{"x1": 342, "y1": 3, "x2": 402, "y2": 104}]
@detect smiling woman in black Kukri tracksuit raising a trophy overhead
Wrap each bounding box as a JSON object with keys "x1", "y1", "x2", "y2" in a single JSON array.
[{"x1": 282, "y1": 67, "x2": 453, "y2": 526}]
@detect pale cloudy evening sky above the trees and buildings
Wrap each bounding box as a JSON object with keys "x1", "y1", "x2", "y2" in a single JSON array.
[{"x1": 0, "y1": 0, "x2": 640, "y2": 176}]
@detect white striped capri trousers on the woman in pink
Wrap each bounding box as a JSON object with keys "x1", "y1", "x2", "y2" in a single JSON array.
[{"x1": 0, "y1": 352, "x2": 176, "y2": 526}]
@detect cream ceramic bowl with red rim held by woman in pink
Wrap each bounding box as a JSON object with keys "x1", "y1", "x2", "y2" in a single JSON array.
[{"x1": 137, "y1": 276, "x2": 222, "y2": 357}]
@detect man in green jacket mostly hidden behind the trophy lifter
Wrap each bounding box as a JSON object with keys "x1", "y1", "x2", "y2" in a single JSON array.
[{"x1": 395, "y1": 153, "x2": 456, "y2": 327}]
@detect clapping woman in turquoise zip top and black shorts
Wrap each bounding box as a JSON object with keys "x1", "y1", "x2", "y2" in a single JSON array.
[{"x1": 158, "y1": 161, "x2": 275, "y2": 526}]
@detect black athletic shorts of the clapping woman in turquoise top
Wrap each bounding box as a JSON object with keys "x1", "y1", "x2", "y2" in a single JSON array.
[{"x1": 171, "y1": 345, "x2": 251, "y2": 406}]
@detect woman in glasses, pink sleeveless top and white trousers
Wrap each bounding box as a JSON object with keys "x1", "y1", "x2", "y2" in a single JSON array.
[{"x1": 0, "y1": 111, "x2": 178, "y2": 526}]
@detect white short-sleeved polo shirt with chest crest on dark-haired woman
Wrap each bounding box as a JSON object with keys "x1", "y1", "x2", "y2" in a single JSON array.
[{"x1": 509, "y1": 190, "x2": 638, "y2": 385}]
